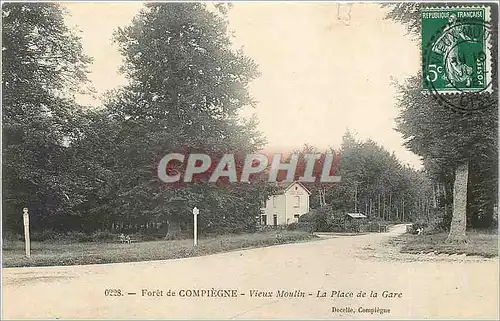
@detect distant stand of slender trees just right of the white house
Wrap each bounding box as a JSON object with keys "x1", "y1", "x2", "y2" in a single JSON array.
[{"x1": 297, "y1": 131, "x2": 434, "y2": 222}]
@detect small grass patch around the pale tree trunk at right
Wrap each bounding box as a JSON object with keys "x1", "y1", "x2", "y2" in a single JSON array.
[{"x1": 391, "y1": 232, "x2": 498, "y2": 258}]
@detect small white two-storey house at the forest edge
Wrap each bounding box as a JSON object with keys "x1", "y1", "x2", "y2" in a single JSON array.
[{"x1": 260, "y1": 182, "x2": 311, "y2": 225}]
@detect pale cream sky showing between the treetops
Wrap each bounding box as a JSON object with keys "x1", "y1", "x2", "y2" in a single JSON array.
[{"x1": 64, "y1": 2, "x2": 421, "y2": 168}]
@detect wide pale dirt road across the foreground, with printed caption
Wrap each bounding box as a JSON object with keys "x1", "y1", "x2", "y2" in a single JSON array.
[{"x1": 2, "y1": 226, "x2": 499, "y2": 319}]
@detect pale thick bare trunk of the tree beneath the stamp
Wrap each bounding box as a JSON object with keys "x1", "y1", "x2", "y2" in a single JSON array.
[{"x1": 447, "y1": 163, "x2": 469, "y2": 242}]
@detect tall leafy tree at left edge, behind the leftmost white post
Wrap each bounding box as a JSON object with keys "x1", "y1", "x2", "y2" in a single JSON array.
[{"x1": 2, "y1": 2, "x2": 90, "y2": 229}]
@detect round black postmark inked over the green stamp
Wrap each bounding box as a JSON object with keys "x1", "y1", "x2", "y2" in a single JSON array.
[{"x1": 422, "y1": 15, "x2": 498, "y2": 112}]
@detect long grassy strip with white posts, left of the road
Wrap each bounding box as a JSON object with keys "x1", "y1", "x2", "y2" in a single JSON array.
[{"x1": 2, "y1": 231, "x2": 316, "y2": 267}]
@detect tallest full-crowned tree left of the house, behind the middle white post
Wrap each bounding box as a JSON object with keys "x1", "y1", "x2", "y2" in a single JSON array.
[{"x1": 84, "y1": 3, "x2": 267, "y2": 231}]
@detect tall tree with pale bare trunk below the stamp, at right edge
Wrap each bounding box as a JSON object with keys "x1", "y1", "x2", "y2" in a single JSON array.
[{"x1": 384, "y1": 4, "x2": 498, "y2": 241}]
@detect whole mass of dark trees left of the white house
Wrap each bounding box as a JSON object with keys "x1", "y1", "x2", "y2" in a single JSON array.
[{"x1": 2, "y1": 3, "x2": 269, "y2": 232}]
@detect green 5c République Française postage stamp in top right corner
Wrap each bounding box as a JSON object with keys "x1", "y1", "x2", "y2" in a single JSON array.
[{"x1": 421, "y1": 6, "x2": 492, "y2": 94}]
